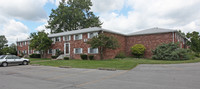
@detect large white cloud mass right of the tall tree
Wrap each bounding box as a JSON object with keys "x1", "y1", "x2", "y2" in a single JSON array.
[{"x1": 93, "y1": 0, "x2": 200, "y2": 33}]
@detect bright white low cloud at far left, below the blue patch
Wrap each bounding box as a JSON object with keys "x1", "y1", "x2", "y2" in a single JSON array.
[{"x1": 0, "y1": 20, "x2": 29, "y2": 44}]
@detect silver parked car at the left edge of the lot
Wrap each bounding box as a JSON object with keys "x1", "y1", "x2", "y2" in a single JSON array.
[{"x1": 0, "y1": 55, "x2": 29, "y2": 67}]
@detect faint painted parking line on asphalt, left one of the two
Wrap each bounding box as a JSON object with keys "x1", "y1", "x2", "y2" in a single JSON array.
[{"x1": 46, "y1": 70, "x2": 96, "y2": 80}]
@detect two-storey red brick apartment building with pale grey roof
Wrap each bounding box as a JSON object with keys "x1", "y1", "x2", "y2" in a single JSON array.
[{"x1": 17, "y1": 27, "x2": 186, "y2": 59}]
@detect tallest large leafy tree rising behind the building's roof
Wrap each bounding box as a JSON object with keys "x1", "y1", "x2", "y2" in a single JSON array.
[{"x1": 46, "y1": 0, "x2": 102, "y2": 33}]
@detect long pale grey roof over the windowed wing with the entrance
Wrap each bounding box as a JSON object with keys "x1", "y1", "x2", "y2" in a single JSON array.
[{"x1": 48, "y1": 27, "x2": 124, "y2": 37}]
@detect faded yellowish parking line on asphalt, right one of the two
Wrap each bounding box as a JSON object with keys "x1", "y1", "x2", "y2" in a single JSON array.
[{"x1": 75, "y1": 70, "x2": 130, "y2": 87}]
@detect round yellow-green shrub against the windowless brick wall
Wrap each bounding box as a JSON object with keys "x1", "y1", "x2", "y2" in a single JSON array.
[{"x1": 131, "y1": 44, "x2": 146, "y2": 58}]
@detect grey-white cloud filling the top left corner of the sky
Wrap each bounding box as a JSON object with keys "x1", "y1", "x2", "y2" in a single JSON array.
[{"x1": 0, "y1": 0, "x2": 48, "y2": 21}]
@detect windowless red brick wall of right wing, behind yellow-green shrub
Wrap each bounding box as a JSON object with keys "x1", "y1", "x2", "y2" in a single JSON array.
[{"x1": 126, "y1": 33, "x2": 173, "y2": 58}]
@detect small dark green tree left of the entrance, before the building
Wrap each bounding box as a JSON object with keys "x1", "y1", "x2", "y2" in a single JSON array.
[{"x1": 29, "y1": 30, "x2": 52, "y2": 57}]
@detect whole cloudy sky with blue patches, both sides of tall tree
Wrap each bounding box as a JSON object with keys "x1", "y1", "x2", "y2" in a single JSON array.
[{"x1": 0, "y1": 0, "x2": 200, "y2": 44}]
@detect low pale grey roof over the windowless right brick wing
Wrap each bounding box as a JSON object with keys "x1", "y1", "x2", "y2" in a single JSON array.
[{"x1": 127, "y1": 27, "x2": 177, "y2": 36}]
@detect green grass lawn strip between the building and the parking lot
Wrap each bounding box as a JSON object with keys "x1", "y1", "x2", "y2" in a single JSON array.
[{"x1": 30, "y1": 58, "x2": 200, "y2": 70}]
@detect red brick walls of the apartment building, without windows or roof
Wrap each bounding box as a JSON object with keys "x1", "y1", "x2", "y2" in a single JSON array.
[{"x1": 17, "y1": 32, "x2": 184, "y2": 59}]
